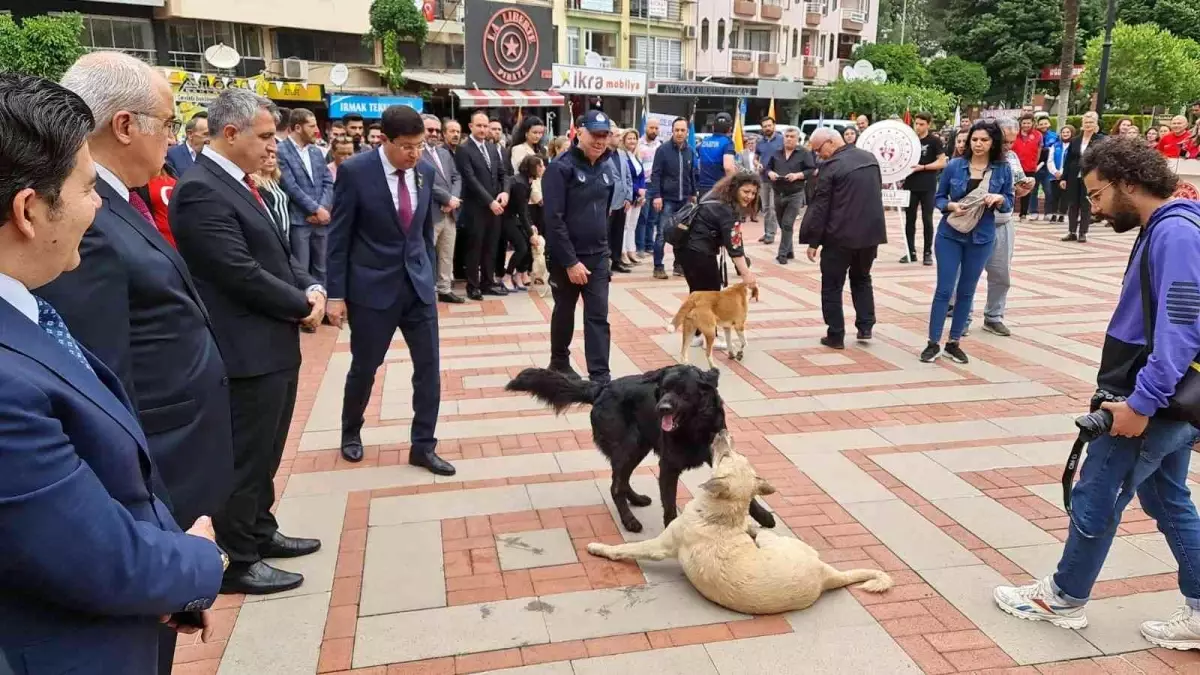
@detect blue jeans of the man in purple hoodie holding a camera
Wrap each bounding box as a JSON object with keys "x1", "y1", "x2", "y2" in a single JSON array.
[{"x1": 1054, "y1": 419, "x2": 1200, "y2": 607}]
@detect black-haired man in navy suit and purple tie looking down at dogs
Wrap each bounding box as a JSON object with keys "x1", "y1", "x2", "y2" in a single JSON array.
[{"x1": 329, "y1": 106, "x2": 455, "y2": 476}]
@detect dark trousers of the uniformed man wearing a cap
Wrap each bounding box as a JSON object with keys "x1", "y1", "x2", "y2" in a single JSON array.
[{"x1": 550, "y1": 255, "x2": 612, "y2": 382}]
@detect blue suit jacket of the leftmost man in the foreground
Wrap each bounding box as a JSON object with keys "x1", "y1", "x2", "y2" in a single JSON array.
[{"x1": 0, "y1": 300, "x2": 221, "y2": 675}]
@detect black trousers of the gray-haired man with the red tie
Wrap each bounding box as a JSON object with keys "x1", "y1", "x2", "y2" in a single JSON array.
[{"x1": 212, "y1": 368, "x2": 300, "y2": 565}]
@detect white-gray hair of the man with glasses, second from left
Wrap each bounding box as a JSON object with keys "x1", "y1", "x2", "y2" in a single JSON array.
[{"x1": 60, "y1": 52, "x2": 162, "y2": 133}]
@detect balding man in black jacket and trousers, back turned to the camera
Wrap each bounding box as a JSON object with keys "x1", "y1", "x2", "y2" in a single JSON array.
[{"x1": 800, "y1": 127, "x2": 888, "y2": 350}]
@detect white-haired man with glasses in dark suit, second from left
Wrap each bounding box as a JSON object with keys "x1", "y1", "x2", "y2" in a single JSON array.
[{"x1": 38, "y1": 52, "x2": 233, "y2": 674}]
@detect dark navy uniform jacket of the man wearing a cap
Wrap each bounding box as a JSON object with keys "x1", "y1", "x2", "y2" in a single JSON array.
[{"x1": 541, "y1": 147, "x2": 616, "y2": 267}]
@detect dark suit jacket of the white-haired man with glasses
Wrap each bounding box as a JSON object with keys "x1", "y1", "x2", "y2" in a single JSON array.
[{"x1": 37, "y1": 180, "x2": 233, "y2": 528}]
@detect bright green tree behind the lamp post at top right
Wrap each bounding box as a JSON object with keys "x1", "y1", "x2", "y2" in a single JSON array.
[{"x1": 1084, "y1": 23, "x2": 1200, "y2": 112}]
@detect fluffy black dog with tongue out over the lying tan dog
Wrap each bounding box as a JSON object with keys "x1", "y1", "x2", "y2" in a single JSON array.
[{"x1": 505, "y1": 365, "x2": 775, "y2": 532}]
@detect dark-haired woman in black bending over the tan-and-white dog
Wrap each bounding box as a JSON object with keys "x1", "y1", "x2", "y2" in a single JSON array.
[{"x1": 676, "y1": 173, "x2": 761, "y2": 293}]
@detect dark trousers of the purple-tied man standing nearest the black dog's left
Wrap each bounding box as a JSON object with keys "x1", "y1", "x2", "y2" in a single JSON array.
[{"x1": 342, "y1": 276, "x2": 442, "y2": 454}]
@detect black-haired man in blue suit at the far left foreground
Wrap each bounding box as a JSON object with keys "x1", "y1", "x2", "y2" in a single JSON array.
[{"x1": 0, "y1": 74, "x2": 223, "y2": 674}]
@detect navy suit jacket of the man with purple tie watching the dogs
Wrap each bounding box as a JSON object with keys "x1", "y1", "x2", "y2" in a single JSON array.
[{"x1": 328, "y1": 151, "x2": 442, "y2": 310}]
